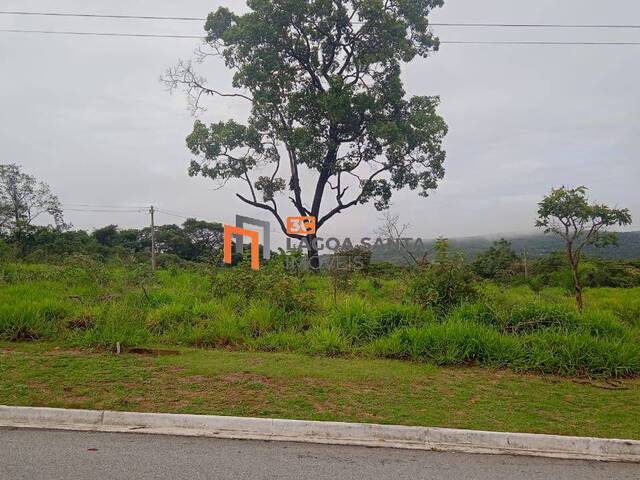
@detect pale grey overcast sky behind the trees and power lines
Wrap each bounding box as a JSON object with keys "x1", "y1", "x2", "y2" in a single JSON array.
[{"x1": 0, "y1": 0, "x2": 640, "y2": 248}]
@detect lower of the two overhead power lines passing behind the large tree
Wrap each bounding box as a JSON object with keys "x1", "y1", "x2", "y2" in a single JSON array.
[{"x1": 0, "y1": 29, "x2": 640, "y2": 46}]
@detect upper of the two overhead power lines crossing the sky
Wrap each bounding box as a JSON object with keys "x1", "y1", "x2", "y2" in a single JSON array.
[{"x1": 0, "y1": 11, "x2": 640, "y2": 29}]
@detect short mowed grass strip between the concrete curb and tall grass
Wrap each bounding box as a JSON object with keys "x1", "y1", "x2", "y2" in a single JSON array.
[{"x1": 0, "y1": 342, "x2": 640, "y2": 439}]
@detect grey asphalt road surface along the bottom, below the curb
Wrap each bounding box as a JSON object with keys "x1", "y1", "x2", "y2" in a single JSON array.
[{"x1": 0, "y1": 427, "x2": 640, "y2": 480}]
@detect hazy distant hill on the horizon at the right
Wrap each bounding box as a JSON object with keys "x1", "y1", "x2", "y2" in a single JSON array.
[{"x1": 373, "y1": 232, "x2": 640, "y2": 265}]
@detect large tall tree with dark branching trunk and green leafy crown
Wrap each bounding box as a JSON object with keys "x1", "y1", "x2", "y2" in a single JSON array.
[{"x1": 164, "y1": 0, "x2": 447, "y2": 267}]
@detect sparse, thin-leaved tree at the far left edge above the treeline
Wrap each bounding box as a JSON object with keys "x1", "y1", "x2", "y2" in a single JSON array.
[{"x1": 0, "y1": 164, "x2": 65, "y2": 249}]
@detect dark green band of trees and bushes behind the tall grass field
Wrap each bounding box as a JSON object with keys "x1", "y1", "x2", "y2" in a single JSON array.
[{"x1": 0, "y1": 225, "x2": 640, "y2": 290}]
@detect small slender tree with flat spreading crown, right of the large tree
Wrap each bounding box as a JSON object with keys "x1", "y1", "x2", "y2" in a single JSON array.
[{"x1": 536, "y1": 186, "x2": 631, "y2": 311}]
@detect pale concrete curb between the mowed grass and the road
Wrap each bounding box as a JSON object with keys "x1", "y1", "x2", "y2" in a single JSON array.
[{"x1": 0, "y1": 405, "x2": 640, "y2": 463}]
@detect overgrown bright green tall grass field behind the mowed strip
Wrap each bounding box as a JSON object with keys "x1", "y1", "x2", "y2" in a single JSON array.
[{"x1": 0, "y1": 259, "x2": 640, "y2": 377}]
